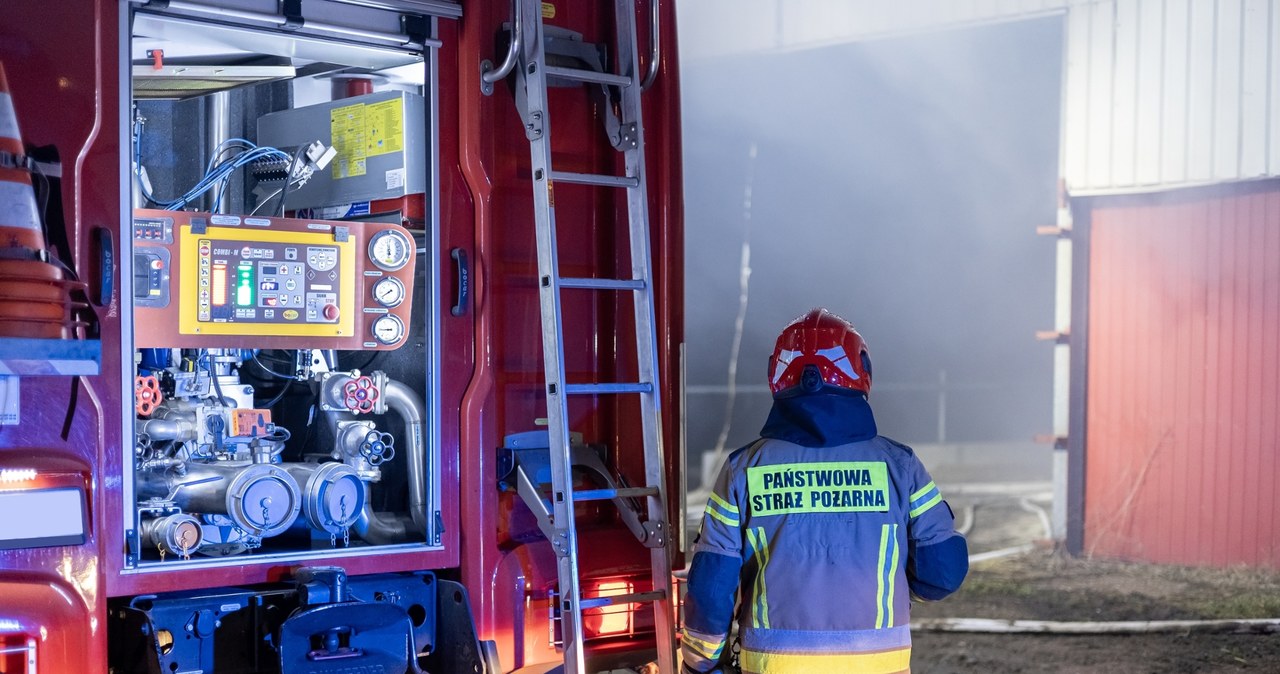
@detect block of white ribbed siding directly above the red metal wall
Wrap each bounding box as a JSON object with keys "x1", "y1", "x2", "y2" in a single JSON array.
[{"x1": 1064, "y1": 0, "x2": 1280, "y2": 193}]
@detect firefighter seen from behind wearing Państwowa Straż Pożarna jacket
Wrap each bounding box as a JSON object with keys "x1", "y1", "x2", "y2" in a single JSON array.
[{"x1": 681, "y1": 308, "x2": 969, "y2": 674}]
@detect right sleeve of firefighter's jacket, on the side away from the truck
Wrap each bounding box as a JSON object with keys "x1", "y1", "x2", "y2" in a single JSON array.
[{"x1": 906, "y1": 454, "x2": 969, "y2": 601}]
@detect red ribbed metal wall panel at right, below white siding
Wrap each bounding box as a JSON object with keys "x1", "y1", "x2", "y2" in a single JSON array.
[{"x1": 1083, "y1": 180, "x2": 1280, "y2": 568}]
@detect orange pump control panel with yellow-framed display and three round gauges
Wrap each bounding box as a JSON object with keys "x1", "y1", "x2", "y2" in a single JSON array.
[{"x1": 133, "y1": 210, "x2": 417, "y2": 349}]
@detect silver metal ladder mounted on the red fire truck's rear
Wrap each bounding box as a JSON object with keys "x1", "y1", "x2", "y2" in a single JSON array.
[{"x1": 485, "y1": 0, "x2": 676, "y2": 674}]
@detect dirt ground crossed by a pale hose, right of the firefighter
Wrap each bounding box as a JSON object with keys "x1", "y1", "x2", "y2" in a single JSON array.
[{"x1": 911, "y1": 550, "x2": 1280, "y2": 674}]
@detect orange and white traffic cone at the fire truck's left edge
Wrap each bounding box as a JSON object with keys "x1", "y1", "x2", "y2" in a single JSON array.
[{"x1": 0, "y1": 64, "x2": 74, "y2": 339}]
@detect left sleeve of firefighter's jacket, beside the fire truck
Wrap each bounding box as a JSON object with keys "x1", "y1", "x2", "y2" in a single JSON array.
[{"x1": 680, "y1": 460, "x2": 742, "y2": 673}]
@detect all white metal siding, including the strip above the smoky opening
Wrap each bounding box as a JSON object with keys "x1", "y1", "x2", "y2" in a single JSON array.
[{"x1": 678, "y1": 0, "x2": 1280, "y2": 194}]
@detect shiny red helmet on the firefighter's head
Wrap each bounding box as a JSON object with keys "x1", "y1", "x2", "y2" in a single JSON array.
[{"x1": 769, "y1": 308, "x2": 872, "y2": 398}]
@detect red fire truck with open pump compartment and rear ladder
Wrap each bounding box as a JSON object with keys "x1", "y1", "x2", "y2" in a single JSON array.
[{"x1": 0, "y1": 0, "x2": 684, "y2": 674}]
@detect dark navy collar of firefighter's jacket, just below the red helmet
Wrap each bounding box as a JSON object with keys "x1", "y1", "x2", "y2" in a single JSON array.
[{"x1": 760, "y1": 393, "x2": 877, "y2": 448}]
